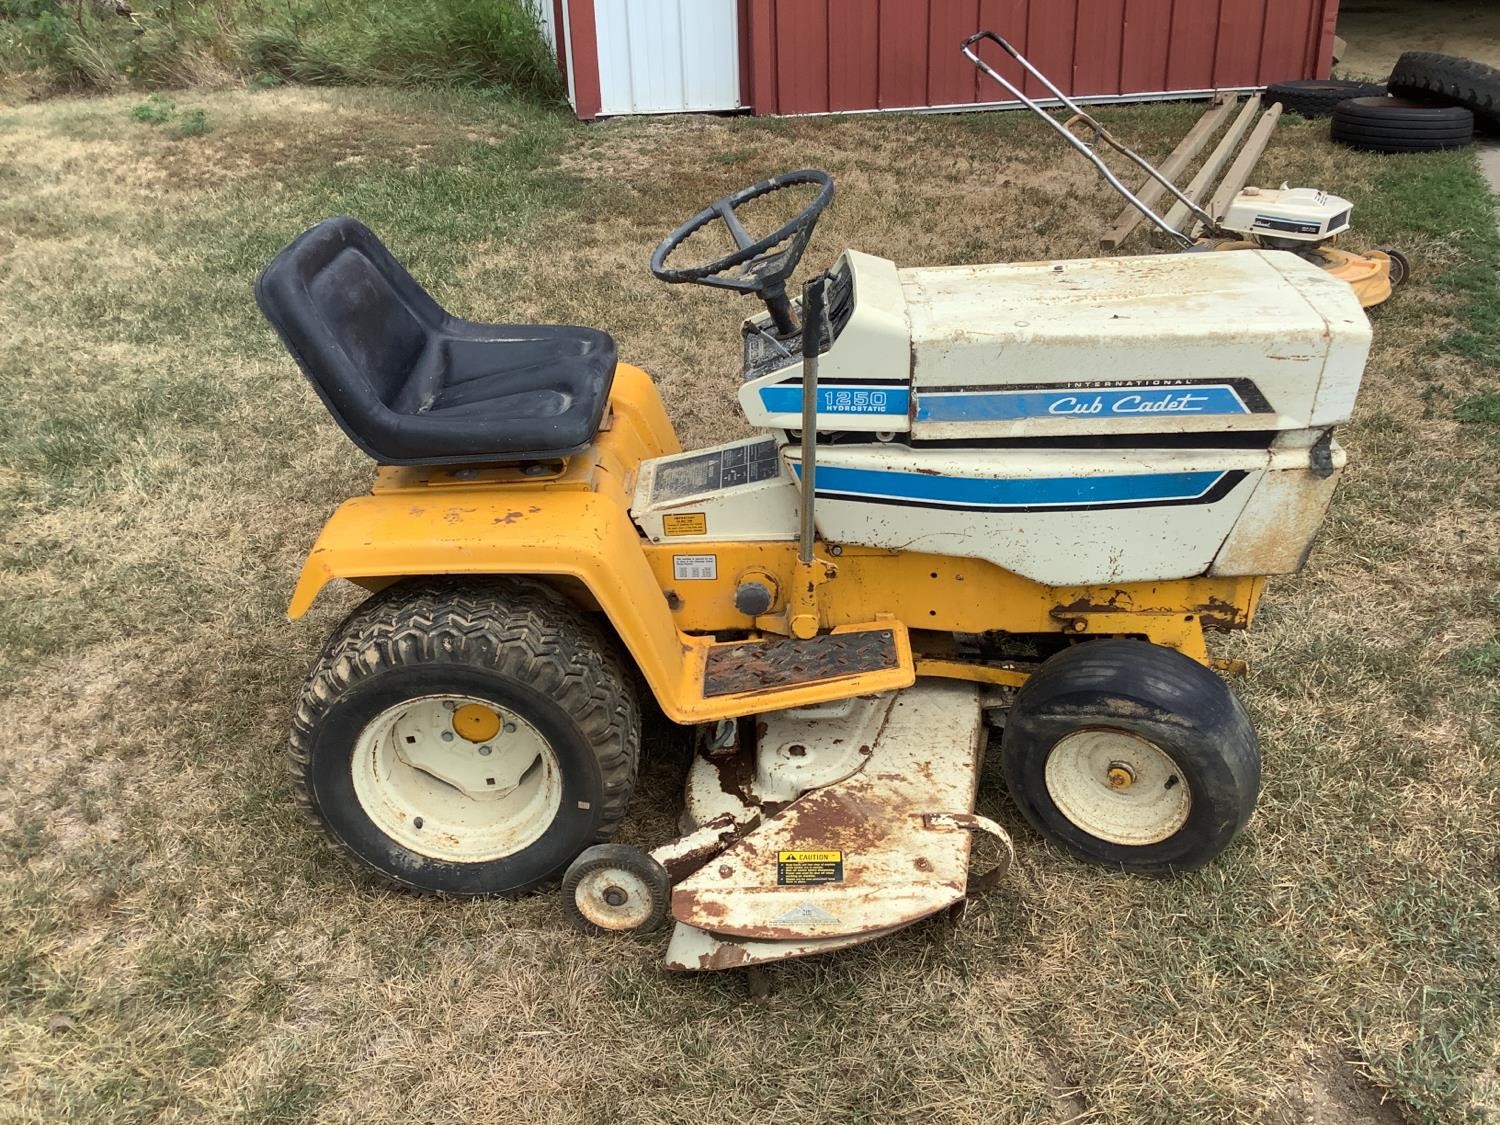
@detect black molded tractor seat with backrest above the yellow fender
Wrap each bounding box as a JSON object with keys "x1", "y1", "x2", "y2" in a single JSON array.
[{"x1": 255, "y1": 218, "x2": 615, "y2": 465}]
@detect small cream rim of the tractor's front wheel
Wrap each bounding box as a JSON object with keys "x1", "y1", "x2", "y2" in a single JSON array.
[{"x1": 1046, "y1": 728, "x2": 1193, "y2": 848}]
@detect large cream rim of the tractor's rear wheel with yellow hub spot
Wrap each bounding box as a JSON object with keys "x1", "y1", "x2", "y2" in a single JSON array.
[{"x1": 351, "y1": 695, "x2": 563, "y2": 864}]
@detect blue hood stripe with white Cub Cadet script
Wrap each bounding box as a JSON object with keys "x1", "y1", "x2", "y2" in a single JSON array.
[{"x1": 917, "y1": 383, "x2": 1251, "y2": 422}]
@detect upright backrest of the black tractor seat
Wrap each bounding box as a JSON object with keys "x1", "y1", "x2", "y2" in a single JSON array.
[{"x1": 255, "y1": 216, "x2": 447, "y2": 414}]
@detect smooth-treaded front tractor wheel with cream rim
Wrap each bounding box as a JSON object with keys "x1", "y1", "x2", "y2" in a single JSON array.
[{"x1": 1001, "y1": 639, "x2": 1260, "y2": 873}]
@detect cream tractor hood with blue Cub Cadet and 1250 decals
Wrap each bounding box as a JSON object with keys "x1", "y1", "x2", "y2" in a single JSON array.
[{"x1": 741, "y1": 251, "x2": 1370, "y2": 441}]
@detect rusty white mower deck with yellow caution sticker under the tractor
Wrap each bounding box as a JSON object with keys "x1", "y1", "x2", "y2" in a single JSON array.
[{"x1": 668, "y1": 680, "x2": 1002, "y2": 969}]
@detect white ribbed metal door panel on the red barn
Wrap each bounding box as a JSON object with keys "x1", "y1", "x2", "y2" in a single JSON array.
[{"x1": 594, "y1": 0, "x2": 740, "y2": 114}]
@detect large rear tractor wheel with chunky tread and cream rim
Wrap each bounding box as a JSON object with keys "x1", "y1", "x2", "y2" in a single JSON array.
[{"x1": 290, "y1": 581, "x2": 641, "y2": 896}]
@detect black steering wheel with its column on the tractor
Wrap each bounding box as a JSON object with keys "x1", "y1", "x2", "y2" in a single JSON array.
[{"x1": 651, "y1": 168, "x2": 834, "y2": 336}]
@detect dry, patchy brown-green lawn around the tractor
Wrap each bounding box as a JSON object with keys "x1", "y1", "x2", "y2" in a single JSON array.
[{"x1": 0, "y1": 87, "x2": 1500, "y2": 1125}]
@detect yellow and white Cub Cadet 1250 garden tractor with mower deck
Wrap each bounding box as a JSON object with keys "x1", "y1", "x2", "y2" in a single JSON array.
[{"x1": 257, "y1": 171, "x2": 1370, "y2": 969}]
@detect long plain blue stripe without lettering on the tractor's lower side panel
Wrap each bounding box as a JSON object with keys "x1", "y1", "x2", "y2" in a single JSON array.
[{"x1": 792, "y1": 464, "x2": 1227, "y2": 509}]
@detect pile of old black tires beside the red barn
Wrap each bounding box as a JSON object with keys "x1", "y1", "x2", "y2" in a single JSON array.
[{"x1": 1265, "y1": 51, "x2": 1500, "y2": 153}]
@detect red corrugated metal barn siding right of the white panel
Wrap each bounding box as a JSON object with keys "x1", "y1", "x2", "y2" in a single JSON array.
[{"x1": 744, "y1": 0, "x2": 1338, "y2": 114}]
